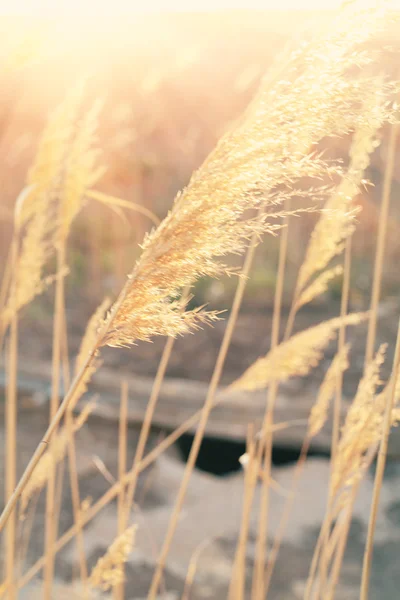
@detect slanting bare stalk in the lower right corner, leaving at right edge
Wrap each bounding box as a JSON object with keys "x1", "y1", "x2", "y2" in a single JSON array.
[{"x1": 360, "y1": 320, "x2": 400, "y2": 600}]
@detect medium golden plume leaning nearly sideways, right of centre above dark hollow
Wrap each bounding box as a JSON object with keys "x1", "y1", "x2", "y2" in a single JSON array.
[{"x1": 228, "y1": 313, "x2": 366, "y2": 391}]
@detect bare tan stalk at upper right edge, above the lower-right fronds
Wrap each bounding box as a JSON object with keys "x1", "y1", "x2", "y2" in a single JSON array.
[{"x1": 364, "y1": 124, "x2": 399, "y2": 365}]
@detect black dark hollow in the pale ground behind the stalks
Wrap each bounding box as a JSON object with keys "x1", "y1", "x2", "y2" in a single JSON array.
[{"x1": 177, "y1": 433, "x2": 329, "y2": 476}]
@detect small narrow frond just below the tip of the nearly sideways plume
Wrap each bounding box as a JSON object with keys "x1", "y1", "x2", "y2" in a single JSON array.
[{"x1": 308, "y1": 344, "x2": 350, "y2": 437}]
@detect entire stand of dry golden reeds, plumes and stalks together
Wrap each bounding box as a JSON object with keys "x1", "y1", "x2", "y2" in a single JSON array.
[{"x1": 0, "y1": 6, "x2": 400, "y2": 600}]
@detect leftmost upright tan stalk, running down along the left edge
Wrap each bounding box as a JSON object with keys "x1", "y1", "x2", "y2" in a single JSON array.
[{"x1": 5, "y1": 234, "x2": 20, "y2": 600}]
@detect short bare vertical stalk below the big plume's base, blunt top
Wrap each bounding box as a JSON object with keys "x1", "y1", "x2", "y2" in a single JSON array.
[{"x1": 113, "y1": 379, "x2": 129, "y2": 600}]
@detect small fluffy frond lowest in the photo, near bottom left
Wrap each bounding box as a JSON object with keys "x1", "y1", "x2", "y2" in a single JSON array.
[{"x1": 89, "y1": 525, "x2": 136, "y2": 591}]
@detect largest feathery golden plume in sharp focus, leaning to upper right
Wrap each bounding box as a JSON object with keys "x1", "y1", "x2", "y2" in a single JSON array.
[{"x1": 102, "y1": 7, "x2": 394, "y2": 346}]
